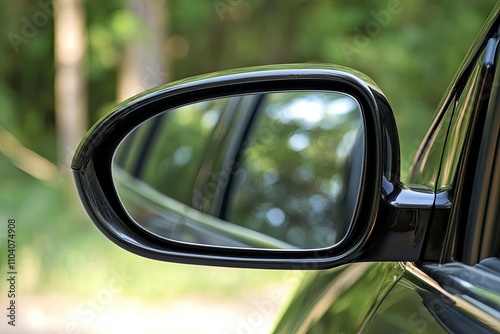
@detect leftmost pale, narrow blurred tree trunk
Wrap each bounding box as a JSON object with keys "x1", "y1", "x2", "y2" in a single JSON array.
[{"x1": 53, "y1": 0, "x2": 87, "y2": 168}]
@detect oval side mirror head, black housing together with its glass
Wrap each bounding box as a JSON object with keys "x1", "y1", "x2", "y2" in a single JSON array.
[{"x1": 72, "y1": 65, "x2": 418, "y2": 269}]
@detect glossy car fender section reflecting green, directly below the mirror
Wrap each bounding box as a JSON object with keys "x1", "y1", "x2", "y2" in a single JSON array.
[{"x1": 273, "y1": 262, "x2": 404, "y2": 333}]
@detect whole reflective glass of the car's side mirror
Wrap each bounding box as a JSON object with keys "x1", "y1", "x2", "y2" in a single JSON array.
[{"x1": 112, "y1": 91, "x2": 364, "y2": 249}]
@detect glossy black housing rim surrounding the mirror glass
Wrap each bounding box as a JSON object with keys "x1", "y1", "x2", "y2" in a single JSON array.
[{"x1": 72, "y1": 65, "x2": 414, "y2": 269}]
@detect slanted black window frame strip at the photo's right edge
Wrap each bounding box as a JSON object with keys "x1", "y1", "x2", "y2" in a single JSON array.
[{"x1": 440, "y1": 35, "x2": 500, "y2": 265}]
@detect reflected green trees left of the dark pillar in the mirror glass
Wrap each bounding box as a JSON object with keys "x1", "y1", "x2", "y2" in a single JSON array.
[{"x1": 115, "y1": 99, "x2": 227, "y2": 205}]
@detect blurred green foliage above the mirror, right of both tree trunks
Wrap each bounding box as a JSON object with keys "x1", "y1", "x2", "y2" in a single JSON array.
[{"x1": 167, "y1": 0, "x2": 494, "y2": 180}]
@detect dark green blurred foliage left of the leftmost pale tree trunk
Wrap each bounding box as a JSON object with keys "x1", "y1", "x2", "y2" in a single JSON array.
[{"x1": 0, "y1": 1, "x2": 55, "y2": 159}]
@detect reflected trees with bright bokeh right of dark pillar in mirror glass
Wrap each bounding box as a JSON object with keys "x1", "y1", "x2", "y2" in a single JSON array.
[{"x1": 228, "y1": 92, "x2": 363, "y2": 248}]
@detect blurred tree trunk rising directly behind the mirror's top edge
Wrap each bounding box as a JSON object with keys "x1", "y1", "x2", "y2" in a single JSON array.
[{"x1": 116, "y1": 0, "x2": 168, "y2": 102}]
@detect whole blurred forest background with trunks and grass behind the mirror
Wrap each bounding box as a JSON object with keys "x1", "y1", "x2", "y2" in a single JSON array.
[{"x1": 0, "y1": 0, "x2": 495, "y2": 332}]
